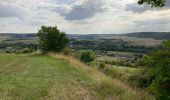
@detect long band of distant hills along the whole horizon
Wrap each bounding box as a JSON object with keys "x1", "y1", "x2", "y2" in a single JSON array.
[{"x1": 0, "y1": 32, "x2": 170, "y2": 40}]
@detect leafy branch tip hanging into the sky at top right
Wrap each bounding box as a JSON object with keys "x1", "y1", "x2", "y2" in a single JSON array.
[{"x1": 138, "y1": 0, "x2": 166, "y2": 7}]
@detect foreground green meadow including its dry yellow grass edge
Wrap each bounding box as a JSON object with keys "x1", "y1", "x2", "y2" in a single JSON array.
[{"x1": 0, "y1": 54, "x2": 153, "y2": 100}]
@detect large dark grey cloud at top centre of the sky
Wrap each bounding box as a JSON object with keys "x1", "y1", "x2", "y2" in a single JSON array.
[{"x1": 50, "y1": 0, "x2": 109, "y2": 21}]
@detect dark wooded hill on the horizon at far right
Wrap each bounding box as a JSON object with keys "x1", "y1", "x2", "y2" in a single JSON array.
[{"x1": 124, "y1": 32, "x2": 170, "y2": 40}]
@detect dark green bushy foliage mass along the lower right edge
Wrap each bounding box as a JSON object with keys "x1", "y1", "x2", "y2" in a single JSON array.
[{"x1": 137, "y1": 41, "x2": 170, "y2": 100}]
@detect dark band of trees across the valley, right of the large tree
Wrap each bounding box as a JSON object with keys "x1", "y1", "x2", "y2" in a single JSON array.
[{"x1": 70, "y1": 39, "x2": 156, "y2": 53}]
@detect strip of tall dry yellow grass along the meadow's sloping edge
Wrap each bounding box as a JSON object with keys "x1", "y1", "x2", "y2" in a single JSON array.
[{"x1": 49, "y1": 53, "x2": 154, "y2": 100}]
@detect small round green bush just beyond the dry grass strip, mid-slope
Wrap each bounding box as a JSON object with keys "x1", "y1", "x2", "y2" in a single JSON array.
[{"x1": 80, "y1": 50, "x2": 96, "y2": 63}]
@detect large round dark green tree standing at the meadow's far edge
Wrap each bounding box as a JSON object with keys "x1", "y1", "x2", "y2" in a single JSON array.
[{"x1": 38, "y1": 26, "x2": 69, "y2": 52}]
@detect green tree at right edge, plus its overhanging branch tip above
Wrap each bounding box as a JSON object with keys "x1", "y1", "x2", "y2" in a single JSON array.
[{"x1": 138, "y1": 0, "x2": 170, "y2": 100}]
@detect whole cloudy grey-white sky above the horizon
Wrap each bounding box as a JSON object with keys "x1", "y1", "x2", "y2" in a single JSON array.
[{"x1": 0, "y1": 0, "x2": 170, "y2": 34}]
